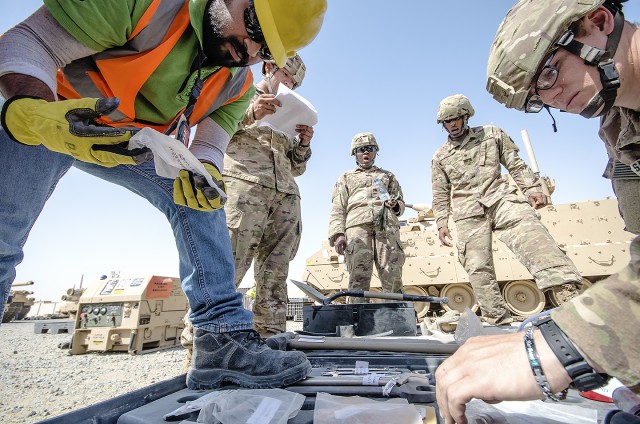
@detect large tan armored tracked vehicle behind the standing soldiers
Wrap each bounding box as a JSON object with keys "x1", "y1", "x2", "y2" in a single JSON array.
[{"x1": 302, "y1": 199, "x2": 633, "y2": 318}]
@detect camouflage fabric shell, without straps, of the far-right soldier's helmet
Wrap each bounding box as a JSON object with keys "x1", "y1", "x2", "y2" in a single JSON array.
[{"x1": 487, "y1": 0, "x2": 604, "y2": 110}]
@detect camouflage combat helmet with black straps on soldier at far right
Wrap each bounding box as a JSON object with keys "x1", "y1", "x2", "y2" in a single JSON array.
[{"x1": 487, "y1": 0, "x2": 626, "y2": 117}]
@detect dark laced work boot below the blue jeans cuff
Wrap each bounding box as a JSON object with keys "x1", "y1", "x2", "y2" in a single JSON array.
[{"x1": 187, "y1": 328, "x2": 311, "y2": 390}]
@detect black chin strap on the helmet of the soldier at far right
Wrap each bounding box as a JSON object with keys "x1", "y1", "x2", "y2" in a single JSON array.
[{"x1": 557, "y1": 10, "x2": 624, "y2": 118}]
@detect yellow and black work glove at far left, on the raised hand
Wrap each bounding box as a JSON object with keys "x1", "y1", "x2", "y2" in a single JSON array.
[{"x1": 2, "y1": 96, "x2": 153, "y2": 167}]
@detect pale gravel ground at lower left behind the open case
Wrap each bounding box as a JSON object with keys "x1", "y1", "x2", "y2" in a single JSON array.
[{"x1": 0, "y1": 321, "x2": 302, "y2": 424}]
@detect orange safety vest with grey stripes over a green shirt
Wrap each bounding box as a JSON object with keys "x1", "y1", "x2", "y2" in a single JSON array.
[{"x1": 57, "y1": 0, "x2": 253, "y2": 132}]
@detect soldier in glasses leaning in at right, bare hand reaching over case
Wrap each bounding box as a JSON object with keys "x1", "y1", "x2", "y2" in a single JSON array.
[{"x1": 436, "y1": 0, "x2": 640, "y2": 423}]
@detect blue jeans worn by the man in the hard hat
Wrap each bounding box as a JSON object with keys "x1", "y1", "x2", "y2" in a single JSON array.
[{"x1": 0, "y1": 129, "x2": 253, "y2": 333}]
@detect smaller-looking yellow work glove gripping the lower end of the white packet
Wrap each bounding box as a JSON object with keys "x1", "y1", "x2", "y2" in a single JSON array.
[{"x1": 173, "y1": 163, "x2": 227, "y2": 212}]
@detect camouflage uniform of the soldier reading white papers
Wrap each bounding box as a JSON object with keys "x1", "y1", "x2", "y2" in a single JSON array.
[{"x1": 222, "y1": 88, "x2": 311, "y2": 337}]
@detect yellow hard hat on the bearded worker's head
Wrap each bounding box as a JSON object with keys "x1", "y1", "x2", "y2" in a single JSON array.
[{"x1": 253, "y1": 0, "x2": 327, "y2": 67}]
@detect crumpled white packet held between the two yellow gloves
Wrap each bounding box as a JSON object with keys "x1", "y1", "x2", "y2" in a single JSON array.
[{"x1": 129, "y1": 128, "x2": 227, "y2": 199}]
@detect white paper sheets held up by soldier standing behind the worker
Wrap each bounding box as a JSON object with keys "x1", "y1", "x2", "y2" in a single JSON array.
[{"x1": 258, "y1": 84, "x2": 318, "y2": 137}]
